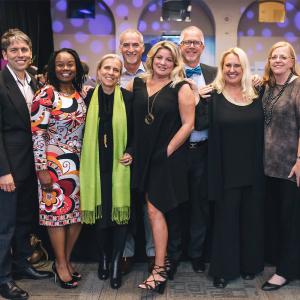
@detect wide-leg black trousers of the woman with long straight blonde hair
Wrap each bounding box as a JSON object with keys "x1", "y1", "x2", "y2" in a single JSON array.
[{"x1": 209, "y1": 187, "x2": 264, "y2": 280}]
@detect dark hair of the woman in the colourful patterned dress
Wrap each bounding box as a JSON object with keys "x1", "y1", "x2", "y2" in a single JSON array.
[{"x1": 48, "y1": 48, "x2": 84, "y2": 92}]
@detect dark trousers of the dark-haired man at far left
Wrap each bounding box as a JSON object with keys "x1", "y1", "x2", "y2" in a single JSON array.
[{"x1": 0, "y1": 174, "x2": 38, "y2": 283}]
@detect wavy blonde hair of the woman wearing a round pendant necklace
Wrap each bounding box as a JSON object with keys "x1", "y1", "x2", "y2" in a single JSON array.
[{"x1": 140, "y1": 41, "x2": 185, "y2": 87}]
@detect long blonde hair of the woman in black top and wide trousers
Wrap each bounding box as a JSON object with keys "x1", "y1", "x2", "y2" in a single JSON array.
[{"x1": 212, "y1": 47, "x2": 257, "y2": 100}]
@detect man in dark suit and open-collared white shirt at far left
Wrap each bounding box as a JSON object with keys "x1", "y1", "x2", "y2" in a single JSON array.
[{"x1": 0, "y1": 29, "x2": 52, "y2": 299}]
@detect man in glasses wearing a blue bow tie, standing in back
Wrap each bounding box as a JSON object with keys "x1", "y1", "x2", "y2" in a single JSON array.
[{"x1": 168, "y1": 26, "x2": 217, "y2": 277}]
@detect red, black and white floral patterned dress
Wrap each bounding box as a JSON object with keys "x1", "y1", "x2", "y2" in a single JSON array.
[{"x1": 31, "y1": 85, "x2": 86, "y2": 226}]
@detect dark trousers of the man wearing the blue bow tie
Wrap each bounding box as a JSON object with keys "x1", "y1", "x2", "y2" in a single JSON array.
[{"x1": 166, "y1": 143, "x2": 209, "y2": 260}]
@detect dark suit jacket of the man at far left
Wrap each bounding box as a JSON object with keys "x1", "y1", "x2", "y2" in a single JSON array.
[{"x1": 0, "y1": 68, "x2": 37, "y2": 182}]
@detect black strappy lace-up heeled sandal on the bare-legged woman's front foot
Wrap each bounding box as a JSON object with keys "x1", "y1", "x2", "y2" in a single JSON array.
[{"x1": 139, "y1": 265, "x2": 168, "y2": 294}]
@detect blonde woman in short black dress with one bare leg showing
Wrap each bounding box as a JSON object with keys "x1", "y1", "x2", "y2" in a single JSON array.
[{"x1": 128, "y1": 41, "x2": 195, "y2": 293}]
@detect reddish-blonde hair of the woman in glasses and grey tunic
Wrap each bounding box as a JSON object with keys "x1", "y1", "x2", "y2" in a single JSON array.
[{"x1": 263, "y1": 41, "x2": 300, "y2": 86}]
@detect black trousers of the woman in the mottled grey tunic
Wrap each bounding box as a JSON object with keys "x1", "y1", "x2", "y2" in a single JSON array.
[{"x1": 266, "y1": 177, "x2": 300, "y2": 279}]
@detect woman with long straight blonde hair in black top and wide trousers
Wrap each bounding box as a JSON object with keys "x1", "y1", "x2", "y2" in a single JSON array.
[{"x1": 208, "y1": 48, "x2": 264, "y2": 288}]
